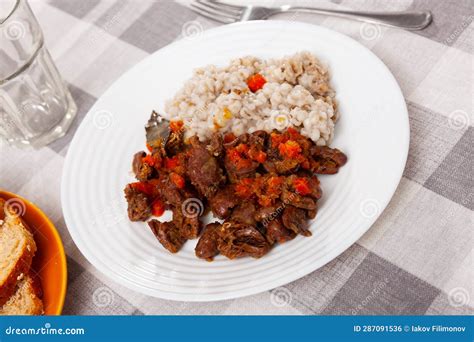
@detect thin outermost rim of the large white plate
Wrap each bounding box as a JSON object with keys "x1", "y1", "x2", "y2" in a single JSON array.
[{"x1": 61, "y1": 20, "x2": 410, "y2": 302}]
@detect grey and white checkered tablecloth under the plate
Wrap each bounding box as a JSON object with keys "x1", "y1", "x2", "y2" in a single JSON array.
[{"x1": 0, "y1": 0, "x2": 474, "y2": 315}]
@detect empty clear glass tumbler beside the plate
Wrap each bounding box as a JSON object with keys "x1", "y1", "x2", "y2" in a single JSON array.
[{"x1": 0, "y1": 0, "x2": 77, "y2": 148}]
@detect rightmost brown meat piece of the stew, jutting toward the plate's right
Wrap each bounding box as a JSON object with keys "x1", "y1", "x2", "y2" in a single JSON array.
[{"x1": 310, "y1": 146, "x2": 347, "y2": 175}]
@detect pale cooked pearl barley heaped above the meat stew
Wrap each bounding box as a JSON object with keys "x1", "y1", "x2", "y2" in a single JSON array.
[{"x1": 165, "y1": 52, "x2": 338, "y2": 145}]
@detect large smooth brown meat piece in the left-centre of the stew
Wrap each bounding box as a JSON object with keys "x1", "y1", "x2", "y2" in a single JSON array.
[{"x1": 186, "y1": 139, "x2": 226, "y2": 198}]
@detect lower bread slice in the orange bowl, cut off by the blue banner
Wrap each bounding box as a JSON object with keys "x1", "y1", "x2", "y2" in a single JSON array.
[{"x1": 0, "y1": 275, "x2": 43, "y2": 316}]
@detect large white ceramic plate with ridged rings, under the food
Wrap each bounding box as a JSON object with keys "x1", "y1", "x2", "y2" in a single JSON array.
[{"x1": 61, "y1": 21, "x2": 409, "y2": 301}]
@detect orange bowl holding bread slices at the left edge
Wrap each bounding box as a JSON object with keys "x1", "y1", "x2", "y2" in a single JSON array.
[{"x1": 0, "y1": 190, "x2": 67, "y2": 315}]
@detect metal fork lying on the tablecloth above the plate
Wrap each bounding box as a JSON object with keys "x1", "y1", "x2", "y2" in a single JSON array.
[{"x1": 191, "y1": 0, "x2": 432, "y2": 30}]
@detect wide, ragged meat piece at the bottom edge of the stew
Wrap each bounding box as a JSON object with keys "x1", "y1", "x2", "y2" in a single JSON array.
[{"x1": 217, "y1": 221, "x2": 270, "y2": 259}]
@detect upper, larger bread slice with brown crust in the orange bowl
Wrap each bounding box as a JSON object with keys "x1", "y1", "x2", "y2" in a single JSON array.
[{"x1": 0, "y1": 201, "x2": 36, "y2": 306}]
